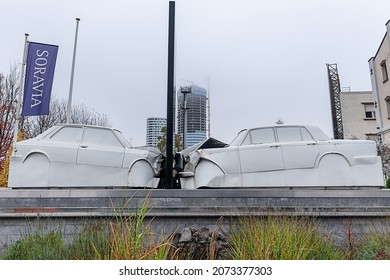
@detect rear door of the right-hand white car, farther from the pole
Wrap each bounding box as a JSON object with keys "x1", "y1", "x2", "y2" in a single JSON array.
[{"x1": 276, "y1": 126, "x2": 319, "y2": 170}]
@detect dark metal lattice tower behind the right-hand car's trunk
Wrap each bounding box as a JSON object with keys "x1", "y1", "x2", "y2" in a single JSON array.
[{"x1": 326, "y1": 63, "x2": 344, "y2": 139}]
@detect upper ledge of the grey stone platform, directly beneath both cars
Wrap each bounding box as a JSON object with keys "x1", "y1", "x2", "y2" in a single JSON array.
[{"x1": 0, "y1": 189, "x2": 390, "y2": 218}]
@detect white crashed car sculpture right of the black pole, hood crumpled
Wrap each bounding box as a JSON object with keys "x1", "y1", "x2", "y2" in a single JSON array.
[{"x1": 176, "y1": 126, "x2": 384, "y2": 189}]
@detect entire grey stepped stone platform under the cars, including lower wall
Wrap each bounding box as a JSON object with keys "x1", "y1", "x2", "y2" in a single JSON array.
[{"x1": 0, "y1": 189, "x2": 390, "y2": 251}]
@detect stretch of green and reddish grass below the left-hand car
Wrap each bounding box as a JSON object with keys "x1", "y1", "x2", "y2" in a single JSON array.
[{"x1": 2, "y1": 197, "x2": 172, "y2": 260}]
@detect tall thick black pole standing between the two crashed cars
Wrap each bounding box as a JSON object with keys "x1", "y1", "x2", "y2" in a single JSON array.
[{"x1": 165, "y1": 1, "x2": 175, "y2": 189}]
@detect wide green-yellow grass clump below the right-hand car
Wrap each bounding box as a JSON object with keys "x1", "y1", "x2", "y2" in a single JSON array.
[{"x1": 230, "y1": 215, "x2": 345, "y2": 260}]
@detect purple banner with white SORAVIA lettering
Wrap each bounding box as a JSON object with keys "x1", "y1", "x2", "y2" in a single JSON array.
[{"x1": 22, "y1": 42, "x2": 58, "y2": 116}]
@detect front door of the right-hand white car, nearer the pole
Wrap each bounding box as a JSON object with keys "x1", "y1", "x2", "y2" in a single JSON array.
[{"x1": 239, "y1": 127, "x2": 284, "y2": 174}]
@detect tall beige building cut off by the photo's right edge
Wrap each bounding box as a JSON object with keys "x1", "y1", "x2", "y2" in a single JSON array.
[{"x1": 368, "y1": 21, "x2": 390, "y2": 144}]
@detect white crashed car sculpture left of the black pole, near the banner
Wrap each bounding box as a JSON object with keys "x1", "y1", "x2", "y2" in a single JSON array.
[{"x1": 8, "y1": 125, "x2": 161, "y2": 188}]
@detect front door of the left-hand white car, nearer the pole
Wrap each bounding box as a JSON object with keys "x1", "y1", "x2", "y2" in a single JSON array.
[{"x1": 77, "y1": 127, "x2": 125, "y2": 168}]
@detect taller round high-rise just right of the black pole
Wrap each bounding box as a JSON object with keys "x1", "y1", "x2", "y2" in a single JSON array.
[{"x1": 177, "y1": 85, "x2": 207, "y2": 148}]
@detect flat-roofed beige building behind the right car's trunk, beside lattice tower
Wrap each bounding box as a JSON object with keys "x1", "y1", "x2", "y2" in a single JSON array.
[{"x1": 340, "y1": 91, "x2": 377, "y2": 140}]
